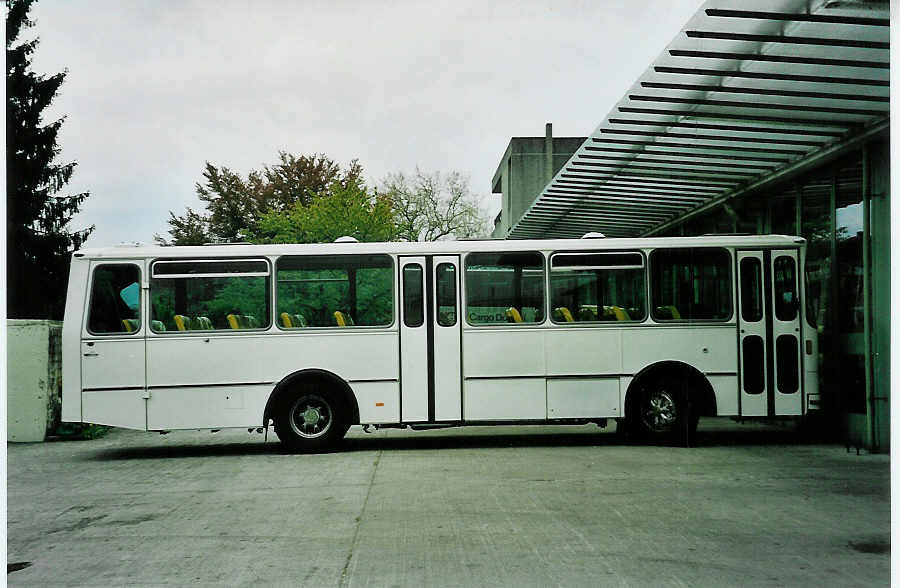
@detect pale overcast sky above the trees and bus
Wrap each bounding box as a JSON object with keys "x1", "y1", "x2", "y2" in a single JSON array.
[{"x1": 29, "y1": 0, "x2": 701, "y2": 246}]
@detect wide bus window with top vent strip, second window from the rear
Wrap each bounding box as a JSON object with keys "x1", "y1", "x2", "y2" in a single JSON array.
[{"x1": 147, "y1": 256, "x2": 276, "y2": 337}]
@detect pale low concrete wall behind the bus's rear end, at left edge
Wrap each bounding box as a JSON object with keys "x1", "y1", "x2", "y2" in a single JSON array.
[{"x1": 6, "y1": 320, "x2": 62, "y2": 442}]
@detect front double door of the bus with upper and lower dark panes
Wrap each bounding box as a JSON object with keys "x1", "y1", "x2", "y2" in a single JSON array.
[{"x1": 737, "y1": 250, "x2": 803, "y2": 417}]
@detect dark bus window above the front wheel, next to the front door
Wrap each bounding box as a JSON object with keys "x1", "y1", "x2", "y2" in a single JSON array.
[{"x1": 650, "y1": 247, "x2": 732, "y2": 321}]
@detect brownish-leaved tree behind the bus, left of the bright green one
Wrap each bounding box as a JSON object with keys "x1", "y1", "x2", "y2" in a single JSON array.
[{"x1": 155, "y1": 151, "x2": 362, "y2": 245}]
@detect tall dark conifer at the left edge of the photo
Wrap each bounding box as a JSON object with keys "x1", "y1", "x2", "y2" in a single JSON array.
[{"x1": 6, "y1": 0, "x2": 94, "y2": 319}]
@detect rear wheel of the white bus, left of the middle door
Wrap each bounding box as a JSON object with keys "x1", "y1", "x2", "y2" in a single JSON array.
[{"x1": 275, "y1": 392, "x2": 346, "y2": 453}]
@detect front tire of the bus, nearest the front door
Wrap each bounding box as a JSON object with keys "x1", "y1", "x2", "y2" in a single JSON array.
[{"x1": 626, "y1": 378, "x2": 700, "y2": 445}]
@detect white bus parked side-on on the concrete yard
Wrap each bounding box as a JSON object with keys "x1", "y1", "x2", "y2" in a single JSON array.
[{"x1": 62, "y1": 235, "x2": 819, "y2": 451}]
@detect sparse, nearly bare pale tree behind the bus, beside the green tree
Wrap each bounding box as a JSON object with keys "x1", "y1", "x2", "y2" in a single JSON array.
[{"x1": 380, "y1": 169, "x2": 489, "y2": 241}]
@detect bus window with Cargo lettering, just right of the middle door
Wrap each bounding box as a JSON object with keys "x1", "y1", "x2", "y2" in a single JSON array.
[{"x1": 466, "y1": 252, "x2": 544, "y2": 325}]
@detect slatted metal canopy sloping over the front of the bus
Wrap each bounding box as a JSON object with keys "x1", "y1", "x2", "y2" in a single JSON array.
[{"x1": 509, "y1": 0, "x2": 890, "y2": 239}]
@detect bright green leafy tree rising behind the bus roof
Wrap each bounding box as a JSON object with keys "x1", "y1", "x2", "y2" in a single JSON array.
[{"x1": 250, "y1": 180, "x2": 397, "y2": 243}]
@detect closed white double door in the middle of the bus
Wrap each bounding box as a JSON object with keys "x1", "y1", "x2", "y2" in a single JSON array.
[{"x1": 399, "y1": 255, "x2": 462, "y2": 423}]
